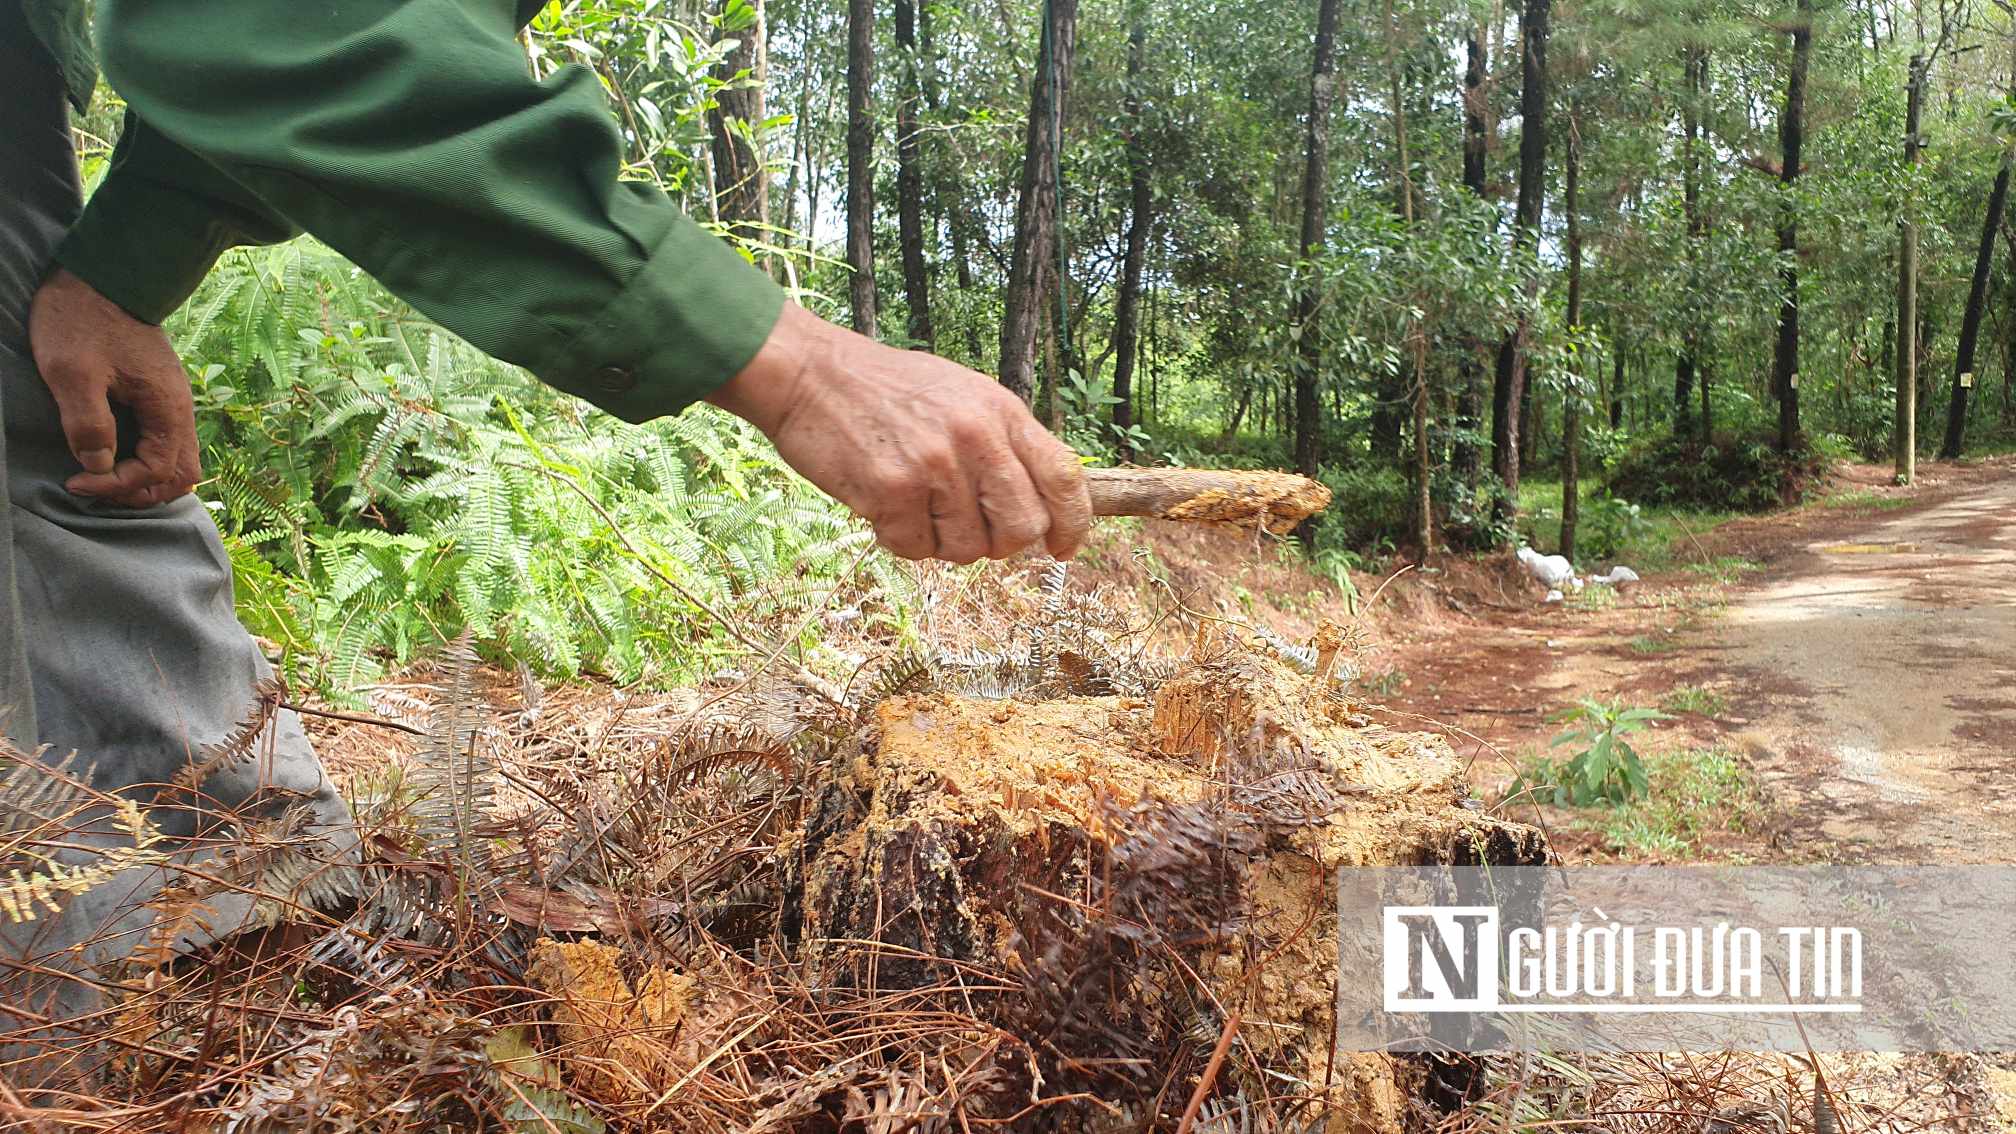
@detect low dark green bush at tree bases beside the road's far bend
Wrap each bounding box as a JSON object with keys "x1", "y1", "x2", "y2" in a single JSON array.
[{"x1": 1611, "y1": 436, "x2": 1829, "y2": 513}]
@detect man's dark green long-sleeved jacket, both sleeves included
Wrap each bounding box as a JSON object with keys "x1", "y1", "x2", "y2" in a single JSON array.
[{"x1": 25, "y1": 0, "x2": 784, "y2": 422}]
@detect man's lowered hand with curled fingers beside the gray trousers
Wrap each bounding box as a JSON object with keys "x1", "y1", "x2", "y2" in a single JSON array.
[{"x1": 28, "y1": 268, "x2": 202, "y2": 508}]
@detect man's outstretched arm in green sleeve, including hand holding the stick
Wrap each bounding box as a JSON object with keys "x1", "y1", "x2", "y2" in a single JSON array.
[{"x1": 55, "y1": 0, "x2": 1091, "y2": 563}]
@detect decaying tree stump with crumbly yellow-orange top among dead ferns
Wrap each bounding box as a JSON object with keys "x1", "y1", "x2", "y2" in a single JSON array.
[{"x1": 786, "y1": 650, "x2": 1546, "y2": 1132}]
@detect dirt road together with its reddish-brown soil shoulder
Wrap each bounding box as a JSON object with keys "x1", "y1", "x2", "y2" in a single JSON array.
[{"x1": 1373, "y1": 460, "x2": 2016, "y2": 864}]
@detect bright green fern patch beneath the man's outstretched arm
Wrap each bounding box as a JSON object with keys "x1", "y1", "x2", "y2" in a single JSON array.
[{"x1": 171, "y1": 242, "x2": 905, "y2": 694}]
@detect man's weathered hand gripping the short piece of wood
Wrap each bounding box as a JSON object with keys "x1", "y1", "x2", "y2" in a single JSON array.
[{"x1": 710, "y1": 305, "x2": 1093, "y2": 563}]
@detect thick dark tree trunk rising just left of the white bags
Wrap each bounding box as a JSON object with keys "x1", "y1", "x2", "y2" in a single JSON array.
[{"x1": 1492, "y1": 0, "x2": 1550, "y2": 517}]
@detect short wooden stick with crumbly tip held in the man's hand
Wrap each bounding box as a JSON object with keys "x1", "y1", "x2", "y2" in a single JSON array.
[{"x1": 1085, "y1": 468, "x2": 1331, "y2": 535}]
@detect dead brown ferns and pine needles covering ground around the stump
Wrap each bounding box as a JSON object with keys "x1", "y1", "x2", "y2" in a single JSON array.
[{"x1": 0, "y1": 575, "x2": 1403, "y2": 1134}]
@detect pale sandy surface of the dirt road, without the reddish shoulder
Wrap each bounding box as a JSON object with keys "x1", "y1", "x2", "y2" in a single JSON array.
[{"x1": 1716, "y1": 468, "x2": 2016, "y2": 862}]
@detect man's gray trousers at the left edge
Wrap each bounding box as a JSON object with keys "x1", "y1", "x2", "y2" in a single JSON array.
[{"x1": 0, "y1": 0, "x2": 349, "y2": 1078}]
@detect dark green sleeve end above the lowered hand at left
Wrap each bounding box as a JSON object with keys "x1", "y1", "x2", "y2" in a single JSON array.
[{"x1": 56, "y1": 113, "x2": 300, "y2": 323}]
